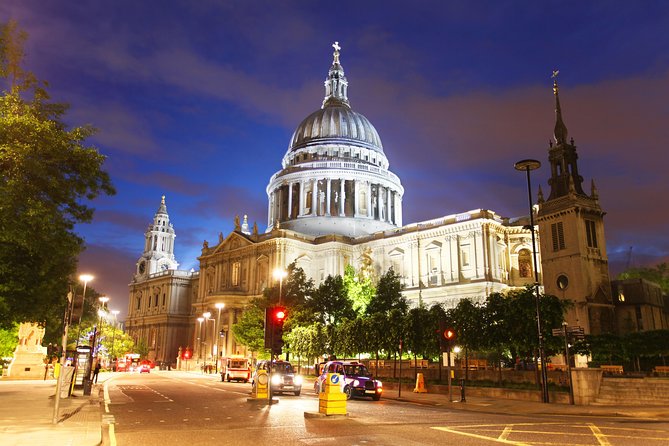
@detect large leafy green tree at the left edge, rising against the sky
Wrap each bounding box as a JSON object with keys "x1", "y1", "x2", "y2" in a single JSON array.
[{"x1": 0, "y1": 21, "x2": 114, "y2": 334}]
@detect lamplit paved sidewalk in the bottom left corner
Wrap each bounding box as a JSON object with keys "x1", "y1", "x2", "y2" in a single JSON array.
[{"x1": 0, "y1": 373, "x2": 109, "y2": 446}]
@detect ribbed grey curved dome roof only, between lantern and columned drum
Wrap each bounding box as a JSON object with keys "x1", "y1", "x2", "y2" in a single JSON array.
[{"x1": 288, "y1": 104, "x2": 383, "y2": 153}]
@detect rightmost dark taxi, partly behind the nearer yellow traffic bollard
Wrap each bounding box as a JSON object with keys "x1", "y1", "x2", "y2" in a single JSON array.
[{"x1": 314, "y1": 361, "x2": 383, "y2": 401}]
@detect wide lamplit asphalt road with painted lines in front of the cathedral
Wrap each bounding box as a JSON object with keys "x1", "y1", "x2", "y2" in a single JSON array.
[{"x1": 105, "y1": 372, "x2": 669, "y2": 446}]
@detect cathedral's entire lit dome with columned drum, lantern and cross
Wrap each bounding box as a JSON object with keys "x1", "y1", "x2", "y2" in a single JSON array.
[{"x1": 267, "y1": 42, "x2": 404, "y2": 237}]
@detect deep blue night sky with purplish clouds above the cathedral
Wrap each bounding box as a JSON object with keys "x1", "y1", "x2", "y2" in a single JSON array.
[{"x1": 0, "y1": 0, "x2": 669, "y2": 317}]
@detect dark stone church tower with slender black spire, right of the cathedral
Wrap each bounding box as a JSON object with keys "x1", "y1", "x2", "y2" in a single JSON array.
[{"x1": 537, "y1": 71, "x2": 615, "y2": 334}]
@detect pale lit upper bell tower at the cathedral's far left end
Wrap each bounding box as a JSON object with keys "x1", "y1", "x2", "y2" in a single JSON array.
[{"x1": 135, "y1": 195, "x2": 179, "y2": 279}]
